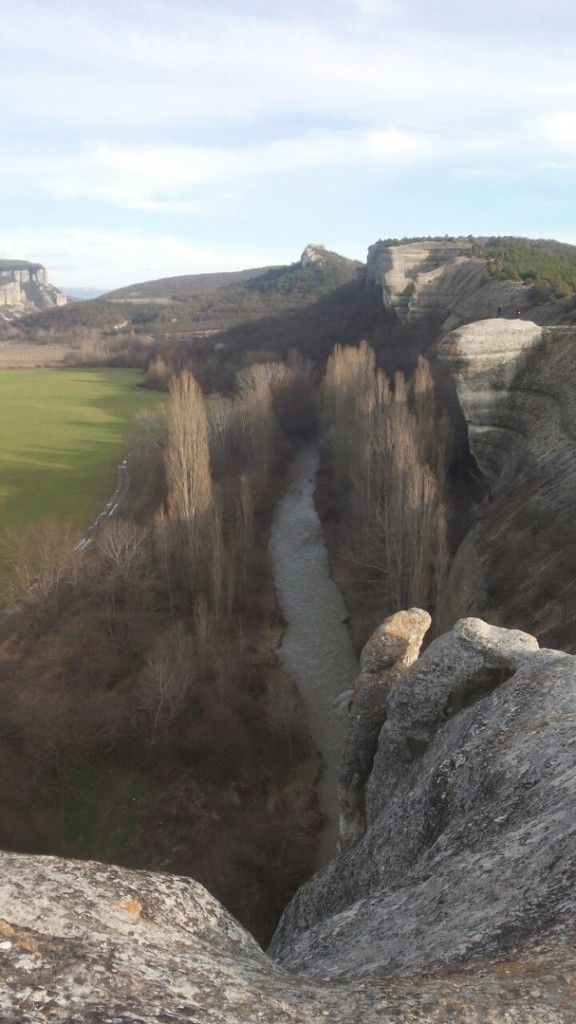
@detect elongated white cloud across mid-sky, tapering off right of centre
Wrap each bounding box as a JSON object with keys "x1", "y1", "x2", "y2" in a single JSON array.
[{"x1": 0, "y1": 127, "x2": 438, "y2": 213}]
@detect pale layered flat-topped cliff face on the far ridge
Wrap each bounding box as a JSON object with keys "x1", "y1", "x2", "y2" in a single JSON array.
[{"x1": 367, "y1": 239, "x2": 548, "y2": 327}]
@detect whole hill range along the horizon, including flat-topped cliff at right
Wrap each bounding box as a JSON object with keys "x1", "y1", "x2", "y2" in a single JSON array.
[{"x1": 14, "y1": 236, "x2": 576, "y2": 373}]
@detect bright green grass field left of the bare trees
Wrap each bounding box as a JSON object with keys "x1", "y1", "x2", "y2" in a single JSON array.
[{"x1": 0, "y1": 370, "x2": 163, "y2": 532}]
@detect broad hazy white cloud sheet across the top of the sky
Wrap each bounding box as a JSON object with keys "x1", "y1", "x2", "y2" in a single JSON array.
[{"x1": 0, "y1": 0, "x2": 576, "y2": 137}]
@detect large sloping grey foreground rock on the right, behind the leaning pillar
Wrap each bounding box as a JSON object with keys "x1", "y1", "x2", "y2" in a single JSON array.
[{"x1": 273, "y1": 620, "x2": 576, "y2": 1003}]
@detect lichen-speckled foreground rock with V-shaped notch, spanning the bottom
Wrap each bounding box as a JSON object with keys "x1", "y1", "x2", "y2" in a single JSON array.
[{"x1": 0, "y1": 620, "x2": 576, "y2": 1024}]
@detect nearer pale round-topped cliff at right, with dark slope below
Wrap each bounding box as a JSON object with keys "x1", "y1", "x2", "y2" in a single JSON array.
[{"x1": 437, "y1": 321, "x2": 576, "y2": 651}]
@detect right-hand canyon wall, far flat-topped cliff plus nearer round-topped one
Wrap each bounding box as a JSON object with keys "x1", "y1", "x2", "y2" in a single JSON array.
[{"x1": 368, "y1": 240, "x2": 576, "y2": 652}]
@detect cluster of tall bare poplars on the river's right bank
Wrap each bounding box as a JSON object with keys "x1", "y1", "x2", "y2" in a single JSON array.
[{"x1": 323, "y1": 343, "x2": 448, "y2": 611}]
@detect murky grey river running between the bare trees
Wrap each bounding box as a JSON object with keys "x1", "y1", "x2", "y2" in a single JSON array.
[{"x1": 270, "y1": 444, "x2": 358, "y2": 867}]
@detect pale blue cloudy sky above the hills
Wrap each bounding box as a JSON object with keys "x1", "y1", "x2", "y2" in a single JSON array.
[{"x1": 0, "y1": 0, "x2": 576, "y2": 289}]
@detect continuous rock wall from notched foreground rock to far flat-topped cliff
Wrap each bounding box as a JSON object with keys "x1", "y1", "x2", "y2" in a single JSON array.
[{"x1": 0, "y1": 235, "x2": 576, "y2": 1024}]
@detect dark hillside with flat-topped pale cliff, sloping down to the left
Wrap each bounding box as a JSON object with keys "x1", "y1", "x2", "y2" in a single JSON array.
[{"x1": 182, "y1": 237, "x2": 576, "y2": 385}]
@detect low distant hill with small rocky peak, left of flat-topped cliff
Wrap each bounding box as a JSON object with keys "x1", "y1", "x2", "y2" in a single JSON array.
[{"x1": 20, "y1": 245, "x2": 362, "y2": 338}]
